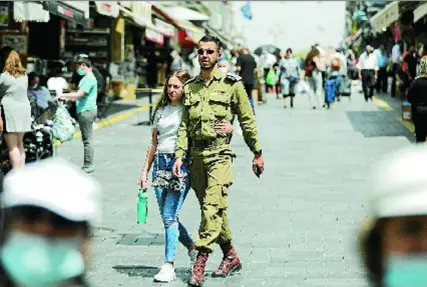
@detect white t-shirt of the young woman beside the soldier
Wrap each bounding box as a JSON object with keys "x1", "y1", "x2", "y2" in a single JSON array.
[{"x1": 154, "y1": 105, "x2": 182, "y2": 153}]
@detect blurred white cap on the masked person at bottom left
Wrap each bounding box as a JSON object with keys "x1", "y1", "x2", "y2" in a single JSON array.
[{"x1": 1, "y1": 158, "x2": 101, "y2": 226}]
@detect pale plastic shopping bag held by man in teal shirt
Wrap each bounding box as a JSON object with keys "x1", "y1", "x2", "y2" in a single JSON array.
[{"x1": 52, "y1": 104, "x2": 76, "y2": 142}]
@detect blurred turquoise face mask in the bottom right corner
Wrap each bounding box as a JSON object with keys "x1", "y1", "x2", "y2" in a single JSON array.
[{"x1": 383, "y1": 254, "x2": 427, "y2": 287}]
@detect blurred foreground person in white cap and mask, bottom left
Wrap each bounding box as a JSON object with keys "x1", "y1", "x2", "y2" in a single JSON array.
[{"x1": 0, "y1": 159, "x2": 101, "y2": 287}]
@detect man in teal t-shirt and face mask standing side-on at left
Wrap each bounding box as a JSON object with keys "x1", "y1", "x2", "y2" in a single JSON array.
[{"x1": 56, "y1": 55, "x2": 98, "y2": 173}]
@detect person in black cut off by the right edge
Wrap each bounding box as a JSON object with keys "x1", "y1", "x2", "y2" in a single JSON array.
[{"x1": 408, "y1": 56, "x2": 427, "y2": 143}]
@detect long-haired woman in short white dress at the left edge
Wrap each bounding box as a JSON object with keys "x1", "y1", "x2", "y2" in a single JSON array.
[{"x1": 0, "y1": 49, "x2": 32, "y2": 168}]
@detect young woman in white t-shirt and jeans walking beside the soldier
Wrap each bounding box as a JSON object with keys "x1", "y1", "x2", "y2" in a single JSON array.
[{"x1": 139, "y1": 70, "x2": 232, "y2": 283}]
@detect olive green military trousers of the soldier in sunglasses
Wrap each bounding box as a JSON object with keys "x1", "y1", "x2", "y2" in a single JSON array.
[{"x1": 190, "y1": 153, "x2": 233, "y2": 252}]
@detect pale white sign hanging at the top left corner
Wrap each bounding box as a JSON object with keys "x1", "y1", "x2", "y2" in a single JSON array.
[{"x1": 13, "y1": 1, "x2": 50, "y2": 22}]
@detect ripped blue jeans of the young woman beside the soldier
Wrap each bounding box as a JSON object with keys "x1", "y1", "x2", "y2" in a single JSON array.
[{"x1": 153, "y1": 153, "x2": 193, "y2": 262}]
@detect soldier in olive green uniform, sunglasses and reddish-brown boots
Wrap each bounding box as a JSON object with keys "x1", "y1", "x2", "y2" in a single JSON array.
[{"x1": 173, "y1": 35, "x2": 264, "y2": 286}]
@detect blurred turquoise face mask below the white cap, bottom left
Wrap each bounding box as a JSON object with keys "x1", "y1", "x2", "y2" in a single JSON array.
[{"x1": 0, "y1": 232, "x2": 85, "y2": 287}]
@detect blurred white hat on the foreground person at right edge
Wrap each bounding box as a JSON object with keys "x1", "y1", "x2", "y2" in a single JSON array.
[{"x1": 371, "y1": 145, "x2": 427, "y2": 218}]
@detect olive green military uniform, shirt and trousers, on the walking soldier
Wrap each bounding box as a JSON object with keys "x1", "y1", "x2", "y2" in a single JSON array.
[{"x1": 176, "y1": 69, "x2": 261, "y2": 252}]
